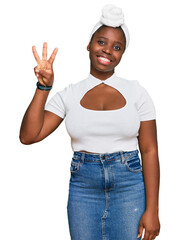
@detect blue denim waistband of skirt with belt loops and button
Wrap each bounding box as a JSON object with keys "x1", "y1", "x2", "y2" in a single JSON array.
[{"x1": 73, "y1": 149, "x2": 139, "y2": 162}]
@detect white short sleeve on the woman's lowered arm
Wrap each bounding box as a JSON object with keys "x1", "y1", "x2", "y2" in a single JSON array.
[{"x1": 136, "y1": 81, "x2": 156, "y2": 121}]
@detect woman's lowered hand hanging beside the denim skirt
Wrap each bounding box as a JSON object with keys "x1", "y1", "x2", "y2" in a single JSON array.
[{"x1": 137, "y1": 210, "x2": 160, "y2": 240}]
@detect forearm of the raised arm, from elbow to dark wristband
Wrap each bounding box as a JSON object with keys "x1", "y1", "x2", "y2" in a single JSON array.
[{"x1": 20, "y1": 89, "x2": 50, "y2": 144}]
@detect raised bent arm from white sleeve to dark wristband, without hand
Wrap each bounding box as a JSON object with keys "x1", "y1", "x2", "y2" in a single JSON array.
[{"x1": 19, "y1": 89, "x2": 63, "y2": 144}]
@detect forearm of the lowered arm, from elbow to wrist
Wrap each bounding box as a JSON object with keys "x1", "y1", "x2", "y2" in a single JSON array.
[{"x1": 141, "y1": 151, "x2": 160, "y2": 212}]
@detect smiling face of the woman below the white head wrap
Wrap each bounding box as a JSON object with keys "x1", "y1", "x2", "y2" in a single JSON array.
[{"x1": 87, "y1": 26, "x2": 125, "y2": 76}]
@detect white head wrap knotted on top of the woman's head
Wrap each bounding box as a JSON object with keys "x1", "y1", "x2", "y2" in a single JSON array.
[{"x1": 89, "y1": 4, "x2": 130, "y2": 48}]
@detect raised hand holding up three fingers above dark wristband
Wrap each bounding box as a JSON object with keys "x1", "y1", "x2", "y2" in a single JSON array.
[{"x1": 32, "y1": 42, "x2": 58, "y2": 86}]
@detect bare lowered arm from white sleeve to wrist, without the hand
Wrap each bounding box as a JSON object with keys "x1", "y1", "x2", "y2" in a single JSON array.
[{"x1": 138, "y1": 120, "x2": 160, "y2": 212}]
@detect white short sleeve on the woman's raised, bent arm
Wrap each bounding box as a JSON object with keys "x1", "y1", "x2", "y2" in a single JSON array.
[{"x1": 44, "y1": 86, "x2": 69, "y2": 118}]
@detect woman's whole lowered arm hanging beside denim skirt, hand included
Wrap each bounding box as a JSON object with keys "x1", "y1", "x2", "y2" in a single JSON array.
[{"x1": 138, "y1": 120, "x2": 160, "y2": 239}]
